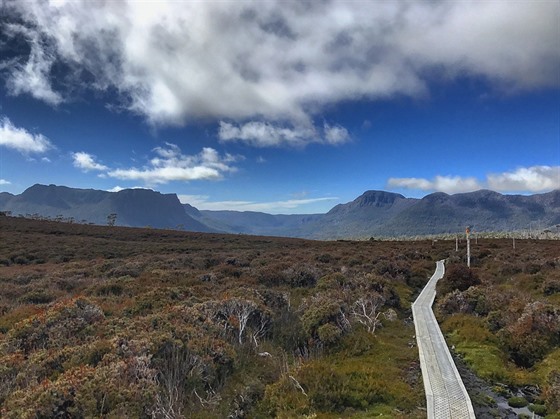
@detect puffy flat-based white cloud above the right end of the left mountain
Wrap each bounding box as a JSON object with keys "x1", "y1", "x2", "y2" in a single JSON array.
[{"x1": 107, "y1": 143, "x2": 242, "y2": 185}]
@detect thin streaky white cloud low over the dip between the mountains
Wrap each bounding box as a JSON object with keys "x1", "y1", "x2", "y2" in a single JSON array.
[{"x1": 178, "y1": 195, "x2": 338, "y2": 214}]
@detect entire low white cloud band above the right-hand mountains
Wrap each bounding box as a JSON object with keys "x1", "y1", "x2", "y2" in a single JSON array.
[{"x1": 387, "y1": 166, "x2": 560, "y2": 193}]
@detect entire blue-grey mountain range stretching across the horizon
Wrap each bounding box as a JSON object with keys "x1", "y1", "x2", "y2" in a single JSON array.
[{"x1": 0, "y1": 185, "x2": 560, "y2": 239}]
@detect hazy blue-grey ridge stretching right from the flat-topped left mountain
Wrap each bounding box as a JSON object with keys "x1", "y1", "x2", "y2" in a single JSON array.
[{"x1": 189, "y1": 190, "x2": 560, "y2": 239}]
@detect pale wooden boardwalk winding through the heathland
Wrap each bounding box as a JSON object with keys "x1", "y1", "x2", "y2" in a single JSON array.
[{"x1": 412, "y1": 261, "x2": 475, "y2": 419}]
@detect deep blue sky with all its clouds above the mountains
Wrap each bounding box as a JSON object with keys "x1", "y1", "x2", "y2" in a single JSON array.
[{"x1": 0, "y1": 0, "x2": 560, "y2": 214}]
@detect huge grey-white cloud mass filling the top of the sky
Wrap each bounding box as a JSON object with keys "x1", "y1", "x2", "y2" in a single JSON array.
[{"x1": 0, "y1": 0, "x2": 560, "y2": 130}]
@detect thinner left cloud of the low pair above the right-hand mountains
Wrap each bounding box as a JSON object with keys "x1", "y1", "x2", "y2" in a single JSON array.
[{"x1": 387, "y1": 176, "x2": 482, "y2": 193}]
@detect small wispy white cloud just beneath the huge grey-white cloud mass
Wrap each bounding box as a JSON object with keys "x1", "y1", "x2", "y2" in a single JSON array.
[{"x1": 218, "y1": 121, "x2": 350, "y2": 147}]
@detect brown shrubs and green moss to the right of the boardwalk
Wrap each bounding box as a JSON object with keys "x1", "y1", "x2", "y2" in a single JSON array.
[{"x1": 435, "y1": 240, "x2": 560, "y2": 418}]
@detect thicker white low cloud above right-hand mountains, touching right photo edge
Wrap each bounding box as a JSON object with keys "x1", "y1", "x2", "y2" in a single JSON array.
[{"x1": 488, "y1": 166, "x2": 560, "y2": 192}]
